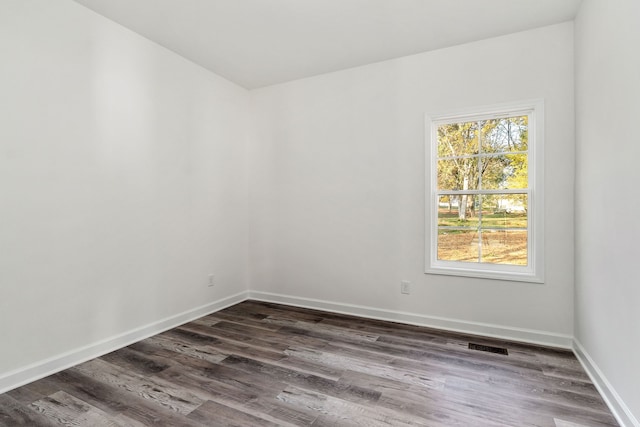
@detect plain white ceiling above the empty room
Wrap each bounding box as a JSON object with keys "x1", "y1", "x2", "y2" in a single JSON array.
[{"x1": 75, "y1": 0, "x2": 581, "y2": 89}]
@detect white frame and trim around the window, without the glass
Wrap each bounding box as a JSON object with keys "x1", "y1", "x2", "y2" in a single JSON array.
[{"x1": 425, "y1": 100, "x2": 544, "y2": 283}]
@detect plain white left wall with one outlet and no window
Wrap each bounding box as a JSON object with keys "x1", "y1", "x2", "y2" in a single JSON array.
[{"x1": 0, "y1": 0, "x2": 249, "y2": 378}]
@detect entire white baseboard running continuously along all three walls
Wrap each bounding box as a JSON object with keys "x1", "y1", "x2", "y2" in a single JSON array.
[{"x1": 7, "y1": 291, "x2": 640, "y2": 427}]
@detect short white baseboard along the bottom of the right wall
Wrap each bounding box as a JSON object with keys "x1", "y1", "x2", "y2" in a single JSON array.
[{"x1": 573, "y1": 338, "x2": 640, "y2": 427}]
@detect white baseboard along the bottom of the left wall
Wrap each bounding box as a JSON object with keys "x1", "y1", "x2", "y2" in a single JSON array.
[{"x1": 0, "y1": 292, "x2": 248, "y2": 394}]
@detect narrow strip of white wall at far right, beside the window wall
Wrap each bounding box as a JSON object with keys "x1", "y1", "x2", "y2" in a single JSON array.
[{"x1": 575, "y1": 0, "x2": 640, "y2": 425}]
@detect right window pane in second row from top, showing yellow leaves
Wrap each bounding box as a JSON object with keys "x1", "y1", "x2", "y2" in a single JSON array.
[{"x1": 480, "y1": 153, "x2": 529, "y2": 190}]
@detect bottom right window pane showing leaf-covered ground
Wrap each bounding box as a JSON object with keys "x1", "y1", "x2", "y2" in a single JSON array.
[{"x1": 481, "y1": 230, "x2": 527, "y2": 265}]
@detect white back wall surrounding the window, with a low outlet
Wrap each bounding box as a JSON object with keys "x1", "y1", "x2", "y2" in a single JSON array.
[{"x1": 249, "y1": 23, "x2": 574, "y2": 342}]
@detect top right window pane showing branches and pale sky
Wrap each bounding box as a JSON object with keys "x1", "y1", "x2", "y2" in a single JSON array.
[{"x1": 479, "y1": 116, "x2": 529, "y2": 153}]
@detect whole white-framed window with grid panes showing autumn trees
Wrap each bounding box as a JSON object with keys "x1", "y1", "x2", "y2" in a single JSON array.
[{"x1": 426, "y1": 101, "x2": 544, "y2": 282}]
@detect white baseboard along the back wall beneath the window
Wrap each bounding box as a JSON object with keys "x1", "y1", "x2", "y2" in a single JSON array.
[{"x1": 249, "y1": 291, "x2": 573, "y2": 350}]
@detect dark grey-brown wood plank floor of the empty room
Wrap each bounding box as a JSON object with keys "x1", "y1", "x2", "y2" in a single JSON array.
[{"x1": 0, "y1": 301, "x2": 617, "y2": 427}]
